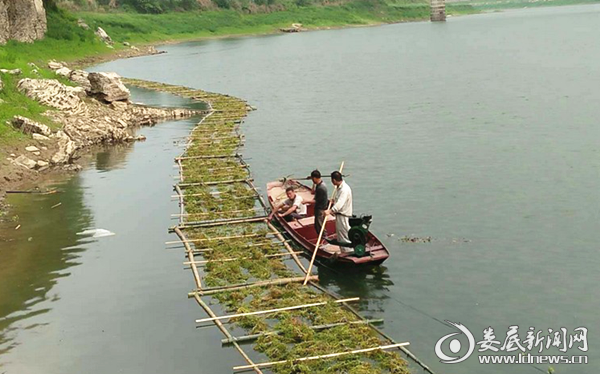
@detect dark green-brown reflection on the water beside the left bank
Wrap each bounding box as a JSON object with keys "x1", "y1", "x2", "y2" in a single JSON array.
[{"x1": 0, "y1": 176, "x2": 92, "y2": 354}]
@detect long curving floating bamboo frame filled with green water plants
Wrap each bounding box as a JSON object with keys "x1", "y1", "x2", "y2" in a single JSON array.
[{"x1": 125, "y1": 79, "x2": 433, "y2": 374}]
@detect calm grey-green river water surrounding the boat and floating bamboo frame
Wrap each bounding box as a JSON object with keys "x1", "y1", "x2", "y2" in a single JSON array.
[{"x1": 0, "y1": 5, "x2": 600, "y2": 374}]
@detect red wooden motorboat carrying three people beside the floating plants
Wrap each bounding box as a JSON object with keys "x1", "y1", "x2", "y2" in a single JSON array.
[{"x1": 267, "y1": 179, "x2": 390, "y2": 266}]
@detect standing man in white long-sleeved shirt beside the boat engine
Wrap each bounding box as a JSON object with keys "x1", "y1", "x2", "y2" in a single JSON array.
[{"x1": 325, "y1": 171, "x2": 353, "y2": 252}]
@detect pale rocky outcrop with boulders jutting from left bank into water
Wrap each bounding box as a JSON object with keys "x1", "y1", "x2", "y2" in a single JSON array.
[{"x1": 11, "y1": 67, "x2": 199, "y2": 170}]
